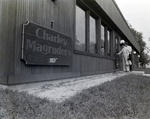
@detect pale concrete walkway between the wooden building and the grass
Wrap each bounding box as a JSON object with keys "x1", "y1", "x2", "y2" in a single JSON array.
[{"x1": 0, "y1": 71, "x2": 143, "y2": 102}]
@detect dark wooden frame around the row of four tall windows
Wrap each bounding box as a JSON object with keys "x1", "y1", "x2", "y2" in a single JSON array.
[{"x1": 73, "y1": 1, "x2": 113, "y2": 59}]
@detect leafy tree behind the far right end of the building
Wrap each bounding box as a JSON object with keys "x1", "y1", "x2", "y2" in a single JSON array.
[{"x1": 129, "y1": 24, "x2": 150, "y2": 67}]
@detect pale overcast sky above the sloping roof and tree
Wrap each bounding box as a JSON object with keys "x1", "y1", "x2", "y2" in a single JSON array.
[{"x1": 115, "y1": 0, "x2": 150, "y2": 48}]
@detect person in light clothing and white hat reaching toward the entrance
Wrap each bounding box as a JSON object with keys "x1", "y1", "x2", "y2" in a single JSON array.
[{"x1": 117, "y1": 40, "x2": 129, "y2": 71}]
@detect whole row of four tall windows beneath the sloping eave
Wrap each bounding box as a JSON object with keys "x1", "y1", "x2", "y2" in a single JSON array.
[{"x1": 75, "y1": 1, "x2": 114, "y2": 57}]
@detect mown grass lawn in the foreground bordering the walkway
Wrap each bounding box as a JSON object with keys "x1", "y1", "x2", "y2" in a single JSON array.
[{"x1": 0, "y1": 75, "x2": 150, "y2": 119}]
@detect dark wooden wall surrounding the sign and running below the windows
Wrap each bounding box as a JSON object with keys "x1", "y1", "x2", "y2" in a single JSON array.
[{"x1": 0, "y1": 0, "x2": 118, "y2": 84}]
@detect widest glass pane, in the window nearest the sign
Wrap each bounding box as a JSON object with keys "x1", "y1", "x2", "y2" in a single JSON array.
[{"x1": 75, "y1": 6, "x2": 86, "y2": 51}]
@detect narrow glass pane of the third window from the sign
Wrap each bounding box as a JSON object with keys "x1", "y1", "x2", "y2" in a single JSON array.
[{"x1": 101, "y1": 25, "x2": 105, "y2": 56}]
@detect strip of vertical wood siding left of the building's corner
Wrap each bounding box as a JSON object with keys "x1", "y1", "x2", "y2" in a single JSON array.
[{"x1": 0, "y1": 0, "x2": 16, "y2": 75}]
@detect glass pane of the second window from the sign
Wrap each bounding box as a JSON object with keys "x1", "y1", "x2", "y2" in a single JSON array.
[{"x1": 90, "y1": 16, "x2": 96, "y2": 53}]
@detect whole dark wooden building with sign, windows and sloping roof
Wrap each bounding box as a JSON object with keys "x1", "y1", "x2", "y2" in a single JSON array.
[{"x1": 0, "y1": 0, "x2": 140, "y2": 85}]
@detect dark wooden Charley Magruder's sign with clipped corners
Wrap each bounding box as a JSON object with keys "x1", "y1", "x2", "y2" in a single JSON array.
[{"x1": 22, "y1": 22, "x2": 73, "y2": 65}]
